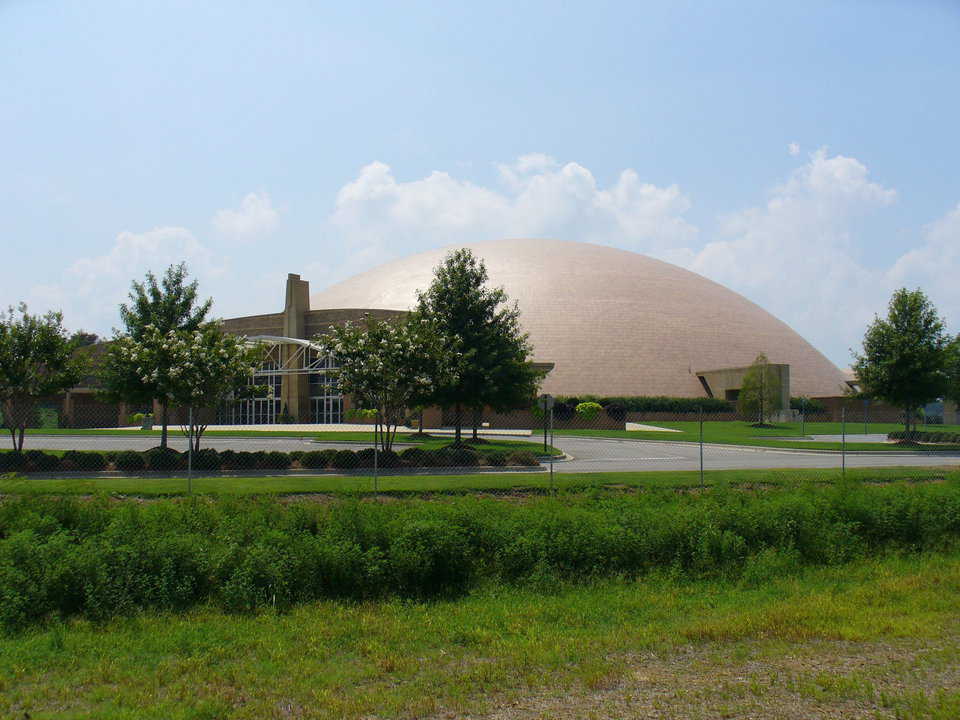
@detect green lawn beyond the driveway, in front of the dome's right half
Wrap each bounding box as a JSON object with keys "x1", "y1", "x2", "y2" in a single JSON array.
[{"x1": 555, "y1": 421, "x2": 960, "y2": 452}]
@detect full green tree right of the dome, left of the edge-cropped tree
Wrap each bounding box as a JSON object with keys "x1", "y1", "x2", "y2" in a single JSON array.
[{"x1": 853, "y1": 288, "x2": 949, "y2": 431}]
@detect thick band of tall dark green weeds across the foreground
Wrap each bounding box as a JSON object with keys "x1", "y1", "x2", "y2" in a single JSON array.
[{"x1": 0, "y1": 482, "x2": 960, "y2": 628}]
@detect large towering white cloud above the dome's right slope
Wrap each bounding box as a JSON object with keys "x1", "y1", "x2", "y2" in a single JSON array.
[{"x1": 675, "y1": 149, "x2": 944, "y2": 366}]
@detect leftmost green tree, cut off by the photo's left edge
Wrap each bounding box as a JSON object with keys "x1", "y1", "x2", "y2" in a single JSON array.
[{"x1": 0, "y1": 303, "x2": 84, "y2": 450}]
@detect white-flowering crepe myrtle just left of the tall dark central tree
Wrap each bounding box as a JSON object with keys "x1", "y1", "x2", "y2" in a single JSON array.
[{"x1": 315, "y1": 313, "x2": 457, "y2": 450}]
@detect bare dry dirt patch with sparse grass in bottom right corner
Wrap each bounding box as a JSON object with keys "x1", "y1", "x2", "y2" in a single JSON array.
[{"x1": 448, "y1": 634, "x2": 960, "y2": 720}]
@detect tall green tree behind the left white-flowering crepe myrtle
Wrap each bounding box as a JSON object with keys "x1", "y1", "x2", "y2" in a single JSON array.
[{"x1": 108, "y1": 263, "x2": 213, "y2": 448}]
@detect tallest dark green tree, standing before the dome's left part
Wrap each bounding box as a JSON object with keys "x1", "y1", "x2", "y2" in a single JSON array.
[{"x1": 416, "y1": 248, "x2": 541, "y2": 444}]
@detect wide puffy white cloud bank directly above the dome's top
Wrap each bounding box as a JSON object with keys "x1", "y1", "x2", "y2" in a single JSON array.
[{"x1": 330, "y1": 153, "x2": 697, "y2": 259}]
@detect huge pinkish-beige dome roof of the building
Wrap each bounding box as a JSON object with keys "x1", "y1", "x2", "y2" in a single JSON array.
[{"x1": 310, "y1": 240, "x2": 843, "y2": 397}]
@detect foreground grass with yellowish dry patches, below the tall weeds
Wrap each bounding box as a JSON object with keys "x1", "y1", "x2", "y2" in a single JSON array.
[{"x1": 0, "y1": 550, "x2": 960, "y2": 720}]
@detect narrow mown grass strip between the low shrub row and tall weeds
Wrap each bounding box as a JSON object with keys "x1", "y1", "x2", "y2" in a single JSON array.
[{"x1": 0, "y1": 466, "x2": 960, "y2": 498}]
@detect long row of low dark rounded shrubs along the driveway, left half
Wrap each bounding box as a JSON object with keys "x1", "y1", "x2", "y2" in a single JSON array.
[{"x1": 0, "y1": 448, "x2": 539, "y2": 472}]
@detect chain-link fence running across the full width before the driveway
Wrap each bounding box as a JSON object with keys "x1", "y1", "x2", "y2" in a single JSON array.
[{"x1": 0, "y1": 405, "x2": 960, "y2": 497}]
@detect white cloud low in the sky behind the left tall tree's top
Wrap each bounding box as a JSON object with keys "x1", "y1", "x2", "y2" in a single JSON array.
[{"x1": 29, "y1": 227, "x2": 222, "y2": 334}]
